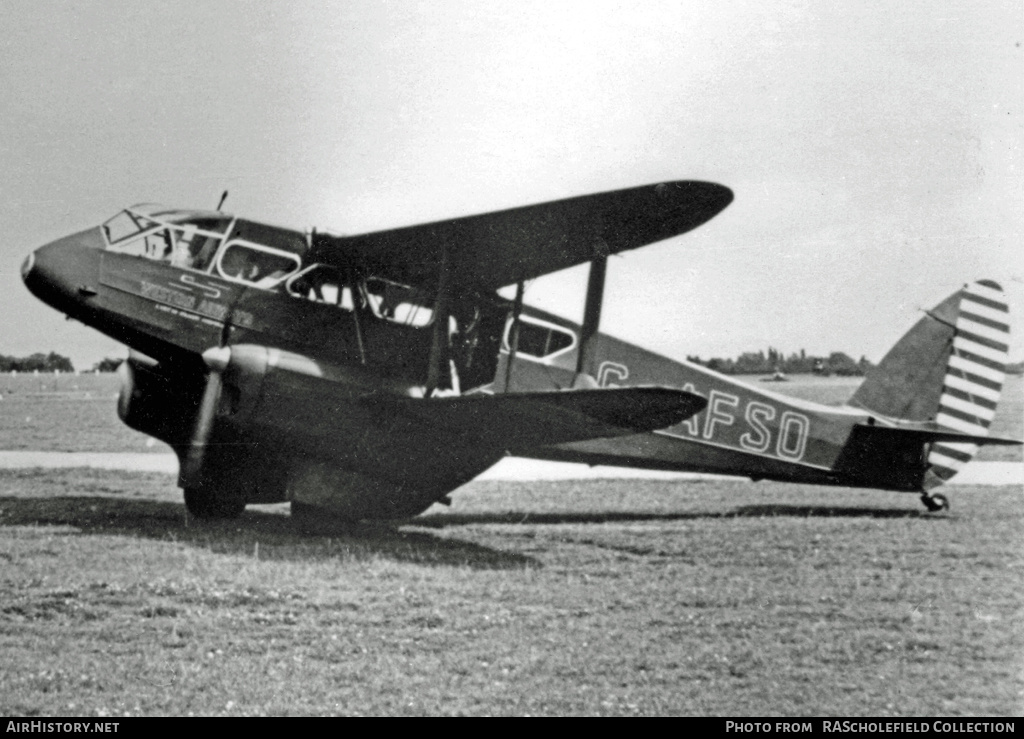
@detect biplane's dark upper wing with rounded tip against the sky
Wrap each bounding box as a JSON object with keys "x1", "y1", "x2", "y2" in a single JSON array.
[{"x1": 310, "y1": 181, "x2": 732, "y2": 291}]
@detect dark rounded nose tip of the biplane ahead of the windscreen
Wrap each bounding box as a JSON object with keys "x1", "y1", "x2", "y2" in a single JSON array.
[{"x1": 22, "y1": 227, "x2": 103, "y2": 314}]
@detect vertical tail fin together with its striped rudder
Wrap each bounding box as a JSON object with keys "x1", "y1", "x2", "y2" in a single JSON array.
[{"x1": 850, "y1": 279, "x2": 1010, "y2": 491}]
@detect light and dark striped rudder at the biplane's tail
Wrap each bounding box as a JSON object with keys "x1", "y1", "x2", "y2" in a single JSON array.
[{"x1": 923, "y1": 279, "x2": 1010, "y2": 490}]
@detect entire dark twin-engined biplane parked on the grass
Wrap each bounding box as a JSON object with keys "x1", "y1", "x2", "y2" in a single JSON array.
[{"x1": 23, "y1": 181, "x2": 1020, "y2": 520}]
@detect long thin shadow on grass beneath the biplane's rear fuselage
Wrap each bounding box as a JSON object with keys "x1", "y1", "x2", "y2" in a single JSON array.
[{"x1": 406, "y1": 505, "x2": 933, "y2": 528}]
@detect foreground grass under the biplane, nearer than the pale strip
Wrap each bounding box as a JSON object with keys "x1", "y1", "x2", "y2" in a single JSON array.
[{"x1": 0, "y1": 470, "x2": 1024, "y2": 715}]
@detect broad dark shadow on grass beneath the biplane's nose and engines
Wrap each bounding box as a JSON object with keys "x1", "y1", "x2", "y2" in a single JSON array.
[{"x1": 0, "y1": 496, "x2": 540, "y2": 569}]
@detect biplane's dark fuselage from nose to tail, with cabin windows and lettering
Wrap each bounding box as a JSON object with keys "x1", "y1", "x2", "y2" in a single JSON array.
[{"x1": 23, "y1": 206, "x2": 924, "y2": 497}]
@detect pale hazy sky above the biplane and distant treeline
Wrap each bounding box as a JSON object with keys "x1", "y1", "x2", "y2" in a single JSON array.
[{"x1": 0, "y1": 0, "x2": 1024, "y2": 368}]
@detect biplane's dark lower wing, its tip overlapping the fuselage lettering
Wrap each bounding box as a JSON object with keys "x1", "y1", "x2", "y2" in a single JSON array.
[{"x1": 362, "y1": 387, "x2": 708, "y2": 451}]
